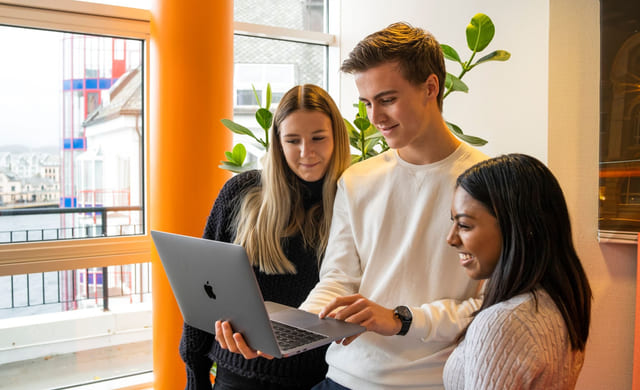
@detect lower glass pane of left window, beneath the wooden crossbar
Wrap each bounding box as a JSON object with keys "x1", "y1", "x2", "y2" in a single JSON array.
[{"x1": 0, "y1": 263, "x2": 153, "y2": 389}]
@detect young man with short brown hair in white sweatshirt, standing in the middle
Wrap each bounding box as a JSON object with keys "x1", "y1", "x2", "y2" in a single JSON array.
[{"x1": 301, "y1": 23, "x2": 486, "y2": 389}]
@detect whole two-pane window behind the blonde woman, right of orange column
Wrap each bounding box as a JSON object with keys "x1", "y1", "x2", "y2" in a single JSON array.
[{"x1": 232, "y1": 0, "x2": 337, "y2": 165}]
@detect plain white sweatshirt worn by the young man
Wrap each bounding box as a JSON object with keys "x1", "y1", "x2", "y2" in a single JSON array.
[{"x1": 301, "y1": 143, "x2": 487, "y2": 390}]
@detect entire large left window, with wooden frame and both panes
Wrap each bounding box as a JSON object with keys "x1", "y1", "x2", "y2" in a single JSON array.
[{"x1": 0, "y1": 0, "x2": 151, "y2": 388}]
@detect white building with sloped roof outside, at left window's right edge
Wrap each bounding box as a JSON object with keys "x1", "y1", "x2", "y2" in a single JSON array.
[{"x1": 76, "y1": 67, "x2": 143, "y2": 235}]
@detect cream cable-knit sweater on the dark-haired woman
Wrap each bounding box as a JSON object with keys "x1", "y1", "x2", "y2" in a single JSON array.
[{"x1": 444, "y1": 290, "x2": 584, "y2": 390}]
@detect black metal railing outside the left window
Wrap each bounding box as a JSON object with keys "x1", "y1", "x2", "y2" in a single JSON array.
[{"x1": 0, "y1": 206, "x2": 151, "y2": 318}]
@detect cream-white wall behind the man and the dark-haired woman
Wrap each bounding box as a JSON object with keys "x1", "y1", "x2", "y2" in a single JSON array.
[{"x1": 339, "y1": 0, "x2": 636, "y2": 390}]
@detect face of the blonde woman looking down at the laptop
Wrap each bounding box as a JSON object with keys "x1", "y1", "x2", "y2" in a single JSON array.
[{"x1": 280, "y1": 110, "x2": 333, "y2": 182}]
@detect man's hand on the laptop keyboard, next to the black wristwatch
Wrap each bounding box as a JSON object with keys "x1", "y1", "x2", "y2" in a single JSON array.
[{"x1": 319, "y1": 294, "x2": 402, "y2": 345}]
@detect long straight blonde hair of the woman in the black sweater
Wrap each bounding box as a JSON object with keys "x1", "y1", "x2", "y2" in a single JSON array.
[{"x1": 234, "y1": 84, "x2": 350, "y2": 274}]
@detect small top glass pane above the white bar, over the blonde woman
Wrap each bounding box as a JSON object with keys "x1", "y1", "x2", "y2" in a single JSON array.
[{"x1": 233, "y1": 0, "x2": 326, "y2": 32}]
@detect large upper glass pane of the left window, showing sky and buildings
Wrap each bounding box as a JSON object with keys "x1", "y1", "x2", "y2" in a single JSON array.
[{"x1": 0, "y1": 26, "x2": 144, "y2": 244}]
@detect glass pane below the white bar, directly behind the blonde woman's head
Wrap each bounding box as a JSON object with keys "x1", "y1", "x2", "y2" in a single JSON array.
[{"x1": 233, "y1": 35, "x2": 327, "y2": 161}]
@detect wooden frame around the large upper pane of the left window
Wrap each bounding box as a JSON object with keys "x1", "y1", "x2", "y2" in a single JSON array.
[{"x1": 0, "y1": 0, "x2": 151, "y2": 276}]
